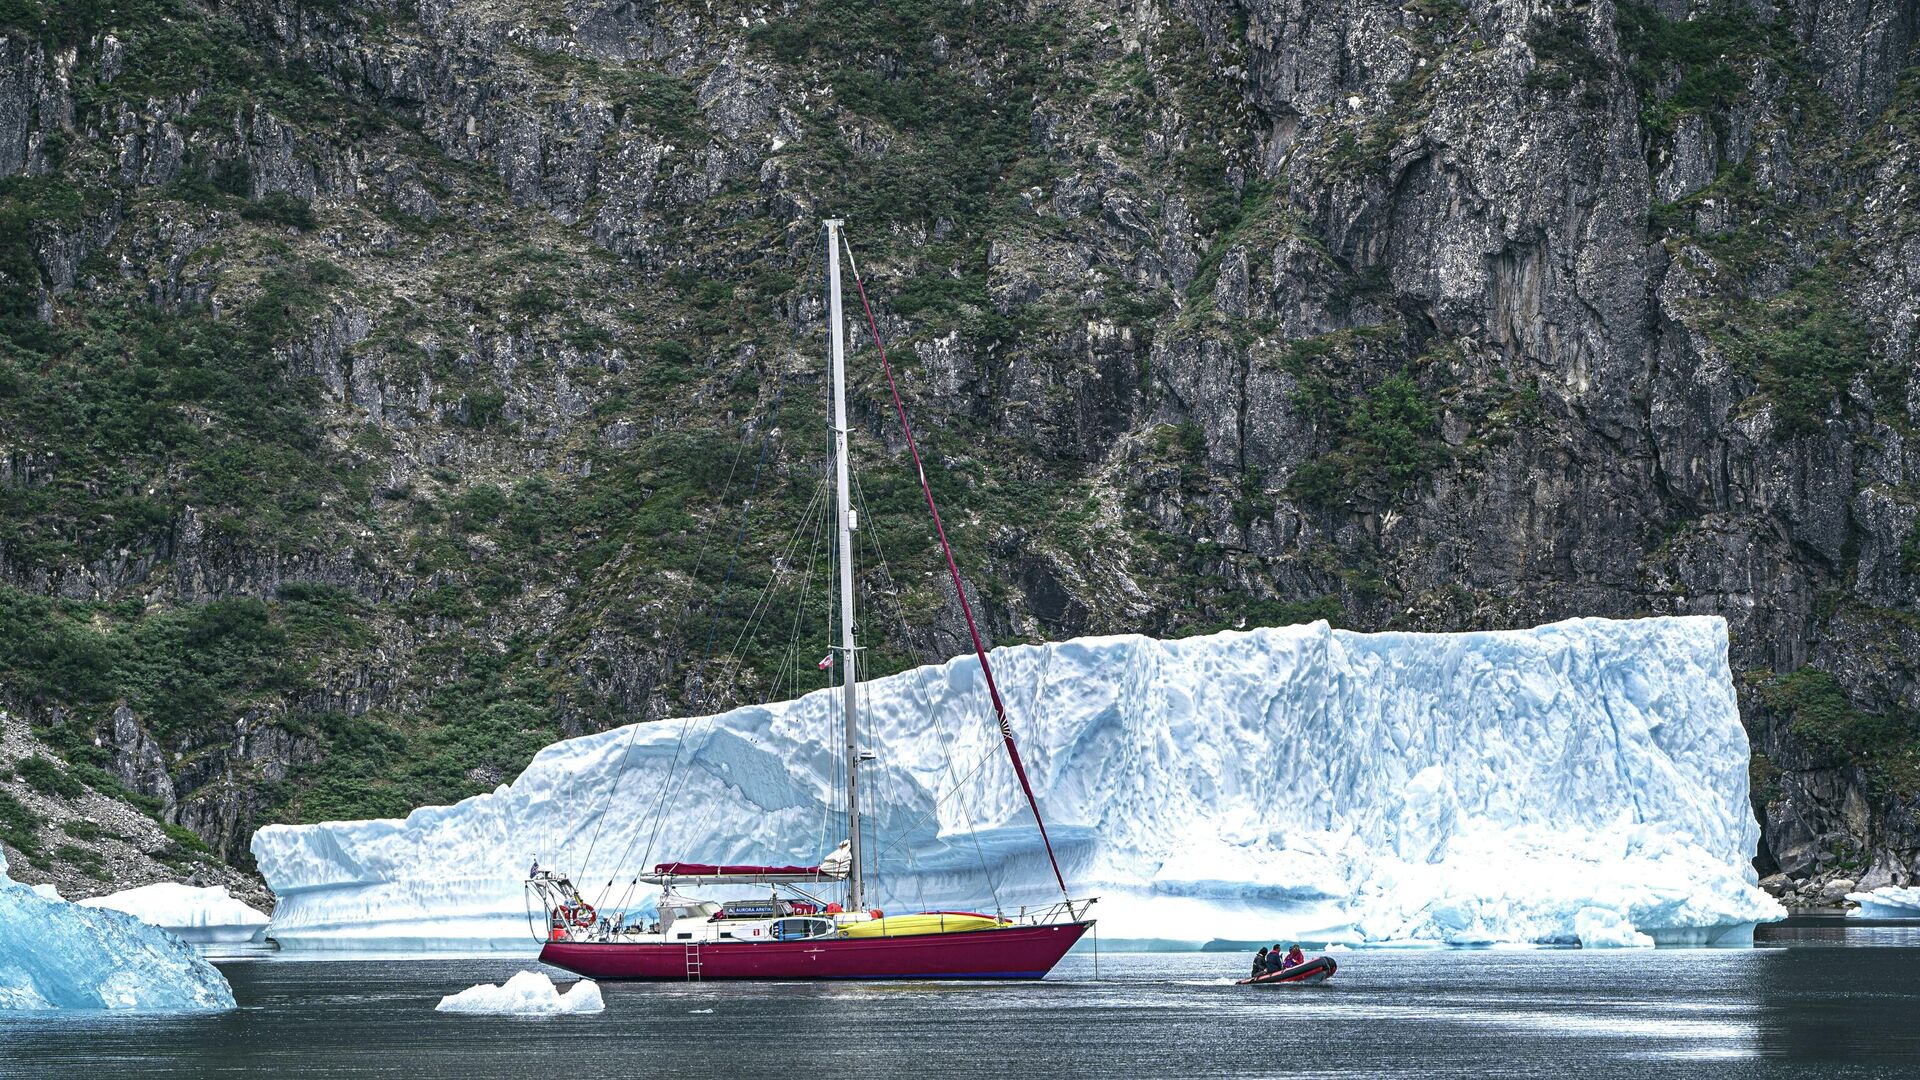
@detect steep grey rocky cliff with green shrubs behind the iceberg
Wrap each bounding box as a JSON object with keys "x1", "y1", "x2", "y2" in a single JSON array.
[{"x1": 0, "y1": 0, "x2": 1920, "y2": 894}]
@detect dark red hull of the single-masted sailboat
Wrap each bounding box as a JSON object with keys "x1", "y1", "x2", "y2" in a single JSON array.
[{"x1": 540, "y1": 922, "x2": 1092, "y2": 982}]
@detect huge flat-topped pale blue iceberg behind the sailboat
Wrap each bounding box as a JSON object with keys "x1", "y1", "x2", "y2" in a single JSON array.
[{"x1": 253, "y1": 617, "x2": 1784, "y2": 949}]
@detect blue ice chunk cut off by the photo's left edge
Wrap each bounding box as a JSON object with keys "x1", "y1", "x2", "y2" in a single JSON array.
[{"x1": 0, "y1": 853, "x2": 234, "y2": 1013}]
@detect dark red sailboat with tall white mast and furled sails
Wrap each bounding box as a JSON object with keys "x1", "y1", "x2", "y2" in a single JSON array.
[{"x1": 528, "y1": 219, "x2": 1094, "y2": 980}]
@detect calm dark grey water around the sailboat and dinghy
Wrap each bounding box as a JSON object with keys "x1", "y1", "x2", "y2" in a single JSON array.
[{"x1": 0, "y1": 928, "x2": 1920, "y2": 1080}]
